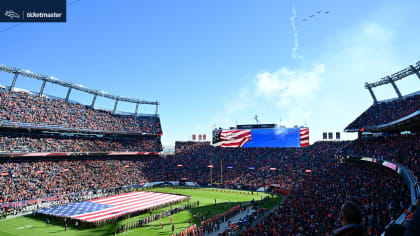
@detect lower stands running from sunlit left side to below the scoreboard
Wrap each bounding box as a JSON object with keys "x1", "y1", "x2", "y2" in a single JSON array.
[{"x1": 0, "y1": 142, "x2": 345, "y2": 210}]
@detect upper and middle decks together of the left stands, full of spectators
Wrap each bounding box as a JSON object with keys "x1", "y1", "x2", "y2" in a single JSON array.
[{"x1": 0, "y1": 89, "x2": 162, "y2": 153}]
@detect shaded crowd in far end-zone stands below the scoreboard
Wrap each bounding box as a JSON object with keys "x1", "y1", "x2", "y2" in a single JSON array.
[{"x1": 143, "y1": 142, "x2": 347, "y2": 188}]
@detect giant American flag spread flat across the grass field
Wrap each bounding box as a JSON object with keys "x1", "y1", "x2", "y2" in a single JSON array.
[{"x1": 37, "y1": 192, "x2": 187, "y2": 222}]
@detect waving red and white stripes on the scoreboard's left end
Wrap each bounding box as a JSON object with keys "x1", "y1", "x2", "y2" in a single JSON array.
[{"x1": 215, "y1": 129, "x2": 251, "y2": 147}]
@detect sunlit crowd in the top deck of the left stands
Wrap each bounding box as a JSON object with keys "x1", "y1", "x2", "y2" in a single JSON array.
[{"x1": 0, "y1": 91, "x2": 162, "y2": 134}]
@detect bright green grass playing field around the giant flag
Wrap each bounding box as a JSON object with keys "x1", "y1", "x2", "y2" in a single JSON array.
[{"x1": 0, "y1": 187, "x2": 282, "y2": 236}]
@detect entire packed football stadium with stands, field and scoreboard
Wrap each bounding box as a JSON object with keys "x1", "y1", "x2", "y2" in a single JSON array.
[{"x1": 0, "y1": 62, "x2": 420, "y2": 235}]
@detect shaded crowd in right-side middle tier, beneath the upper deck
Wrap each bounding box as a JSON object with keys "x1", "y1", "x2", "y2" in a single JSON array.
[{"x1": 341, "y1": 134, "x2": 420, "y2": 176}]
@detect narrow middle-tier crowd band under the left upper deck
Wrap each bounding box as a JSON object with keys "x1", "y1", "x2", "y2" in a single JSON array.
[{"x1": 0, "y1": 135, "x2": 162, "y2": 153}]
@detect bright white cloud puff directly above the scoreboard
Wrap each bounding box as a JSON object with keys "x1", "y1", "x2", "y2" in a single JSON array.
[{"x1": 205, "y1": 64, "x2": 325, "y2": 132}]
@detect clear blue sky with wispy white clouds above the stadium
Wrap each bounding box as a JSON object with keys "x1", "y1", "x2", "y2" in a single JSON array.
[{"x1": 0, "y1": 0, "x2": 420, "y2": 145}]
